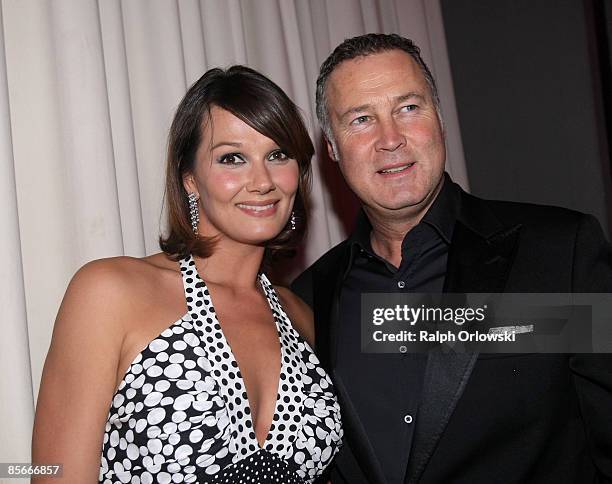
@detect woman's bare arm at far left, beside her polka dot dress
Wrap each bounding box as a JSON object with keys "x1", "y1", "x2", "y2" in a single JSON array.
[{"x1": 32, "y1": 259, "x2": 129, "y2": 484}]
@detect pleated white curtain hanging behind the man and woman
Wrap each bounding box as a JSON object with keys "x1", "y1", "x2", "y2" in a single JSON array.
[{"x1": 0, "y1": 0, "x2": 467, "y2": 468}]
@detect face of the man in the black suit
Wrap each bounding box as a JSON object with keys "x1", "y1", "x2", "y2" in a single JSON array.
[{"x1": 327, "y1": 50, "x2": 445, "y2": 218}]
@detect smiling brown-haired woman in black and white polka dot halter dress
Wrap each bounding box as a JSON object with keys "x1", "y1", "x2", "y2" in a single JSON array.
[{"x1": 33, "y1": 66, "x2": 342, "y2": 484}]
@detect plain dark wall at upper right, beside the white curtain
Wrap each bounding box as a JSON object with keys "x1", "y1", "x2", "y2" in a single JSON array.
[{"x1": 440, "y1": 0, "x2": 612, "y2": 238}]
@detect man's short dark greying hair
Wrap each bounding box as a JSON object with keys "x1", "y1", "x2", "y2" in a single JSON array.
[{"x1": 316, "y1": 34, "x2": 442, "y2": 151}]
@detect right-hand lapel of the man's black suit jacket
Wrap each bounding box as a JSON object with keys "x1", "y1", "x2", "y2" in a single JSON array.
[{"x1": 405, "y1": 199, "x2": 520, "y2": 483}]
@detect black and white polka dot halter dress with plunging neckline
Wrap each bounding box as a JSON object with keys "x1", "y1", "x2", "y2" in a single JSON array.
[{"x1": 100, "y1": 256, "x2": 342, "y2": 484}]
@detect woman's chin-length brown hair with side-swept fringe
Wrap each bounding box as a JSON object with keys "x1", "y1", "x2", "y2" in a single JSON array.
[{"x1": 159, "y1": 65, "x2": 314, "y2": 260}]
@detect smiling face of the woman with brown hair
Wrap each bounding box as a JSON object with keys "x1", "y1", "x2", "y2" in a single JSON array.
[{"x1": 184, "y1": 106, "x2": 299, "y2": 245}]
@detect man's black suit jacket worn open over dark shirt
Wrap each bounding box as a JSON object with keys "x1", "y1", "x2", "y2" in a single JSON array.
[{"x1": 292, "y1": 180, "x2": 612, "y2": 484}]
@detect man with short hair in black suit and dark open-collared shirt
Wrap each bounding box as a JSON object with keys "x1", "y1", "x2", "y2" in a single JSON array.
[{"x1": 293, "y1": 34, "x2": 612, "y2": 484}]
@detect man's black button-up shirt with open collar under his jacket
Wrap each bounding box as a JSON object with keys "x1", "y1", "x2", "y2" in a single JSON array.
[{"x1": 336, "y1": 176, "x2": 460, "y2": 483}]
